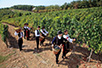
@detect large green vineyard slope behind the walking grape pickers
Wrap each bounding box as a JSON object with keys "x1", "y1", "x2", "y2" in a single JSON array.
[{"x1": 0, "y1": 7, "x2": 102, "y2": 53}]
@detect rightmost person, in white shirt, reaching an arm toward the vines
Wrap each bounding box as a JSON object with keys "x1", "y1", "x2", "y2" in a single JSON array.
[{"x1": 62, "y1": 30, "x2": 75, "y2": 59}]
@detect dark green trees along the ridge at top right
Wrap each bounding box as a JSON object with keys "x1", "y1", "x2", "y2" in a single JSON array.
[{"x1": 61, "y1": 0, "x2": 102, "y2": 9}]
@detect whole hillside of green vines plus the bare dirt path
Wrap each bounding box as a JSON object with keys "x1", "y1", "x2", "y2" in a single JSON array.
[{"x1": 0, "y1": 7, "x2": 102, "y2": 68}]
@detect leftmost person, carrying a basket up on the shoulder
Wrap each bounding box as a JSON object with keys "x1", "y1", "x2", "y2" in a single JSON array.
[{"x1": 14, "y1": 28, "x2": 24, "y2": 51}]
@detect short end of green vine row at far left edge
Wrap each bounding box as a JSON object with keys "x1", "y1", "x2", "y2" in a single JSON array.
[{"x1": 0, "y1": 22, "x2": 8, "y2": 43}]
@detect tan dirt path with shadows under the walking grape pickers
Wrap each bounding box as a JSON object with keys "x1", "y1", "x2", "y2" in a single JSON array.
[{"x1": 0, "y1": 25, "x2": 102, "y2": 68}]
